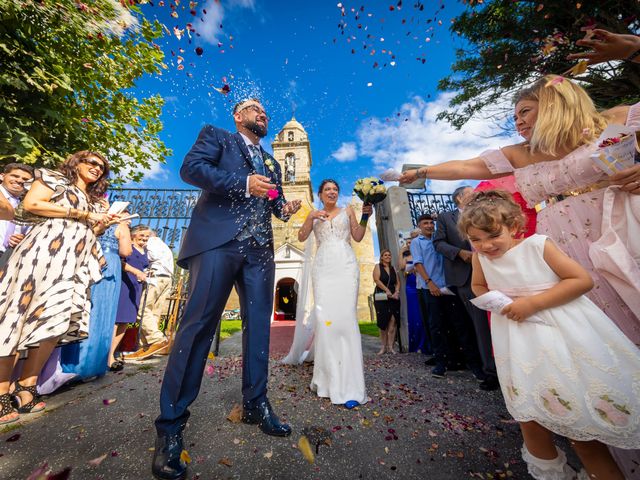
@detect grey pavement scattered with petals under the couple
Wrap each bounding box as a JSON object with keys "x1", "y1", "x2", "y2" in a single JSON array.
[{"x1": 0, "y1": 330, "x2": 575, "y2": 480}]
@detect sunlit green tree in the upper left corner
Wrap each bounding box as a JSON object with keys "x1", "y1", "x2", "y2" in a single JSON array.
[{"x1": 0, "y1": 0, "x2": 170, "y2": 180}]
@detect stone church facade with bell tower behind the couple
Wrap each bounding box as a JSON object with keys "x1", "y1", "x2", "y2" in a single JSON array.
[{"x1": 227, "y1": 118, "x2": 376, "y2": 321}]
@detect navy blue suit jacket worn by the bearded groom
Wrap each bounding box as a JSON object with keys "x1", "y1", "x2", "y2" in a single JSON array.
[{"x1": 178, "y1": 125, "x2": 286, "y2": 268}]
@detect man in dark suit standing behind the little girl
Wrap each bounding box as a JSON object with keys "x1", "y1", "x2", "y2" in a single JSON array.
[{"x1": 433, "y1": 187, "x2": 499, "y2": 390}]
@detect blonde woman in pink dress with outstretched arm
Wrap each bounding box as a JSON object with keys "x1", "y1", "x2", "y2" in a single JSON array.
[{"x1": 401, "y1": 75, "x2": 640, "y2": 345}]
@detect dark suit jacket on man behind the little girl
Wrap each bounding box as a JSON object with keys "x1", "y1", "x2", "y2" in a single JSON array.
[{"x1": 432, "y1": 209, "x2": 471, "y2": 287}]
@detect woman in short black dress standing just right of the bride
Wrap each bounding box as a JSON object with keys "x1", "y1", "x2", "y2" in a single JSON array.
[{"x1": 373, "y1": 249, "x2": 400, "y2": 355}]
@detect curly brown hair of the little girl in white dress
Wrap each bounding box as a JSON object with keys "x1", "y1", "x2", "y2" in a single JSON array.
[{"x1": 458, "y1": 190, "x2": 525, "y2": 237}]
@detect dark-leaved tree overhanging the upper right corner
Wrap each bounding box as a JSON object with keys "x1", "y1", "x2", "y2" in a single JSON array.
[{"x1": 438, "y1": 0, "x2": 640, "y2": 128}]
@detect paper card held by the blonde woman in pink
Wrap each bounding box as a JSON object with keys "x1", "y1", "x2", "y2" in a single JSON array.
[{"x1": 591, "y1": 125, "x2": 638, "y2": 175}]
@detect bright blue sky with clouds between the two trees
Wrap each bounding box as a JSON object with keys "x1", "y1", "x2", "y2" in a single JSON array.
[{"x1": 129, "y1": 0, "x2": 520, "y2": 199}]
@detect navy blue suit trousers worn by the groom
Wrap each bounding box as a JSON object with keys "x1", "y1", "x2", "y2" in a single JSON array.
[{"x1": 155, "y1": 237, "x2": 275, "y2": 435}]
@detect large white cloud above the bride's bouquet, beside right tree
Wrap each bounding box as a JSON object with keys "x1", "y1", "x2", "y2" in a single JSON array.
[{"x1": 357, "y1": 93, "x2": 521, "y2": 193}]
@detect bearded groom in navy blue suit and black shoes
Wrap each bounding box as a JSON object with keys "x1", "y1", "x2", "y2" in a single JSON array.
[{"x1": 152, "y1": 99, "x2": 300, "y2": 479}]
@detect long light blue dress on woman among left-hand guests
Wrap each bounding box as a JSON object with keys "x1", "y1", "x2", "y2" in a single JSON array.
[{"x1": 60, "y1": 225, "x2": 122, "y2": 379}]
